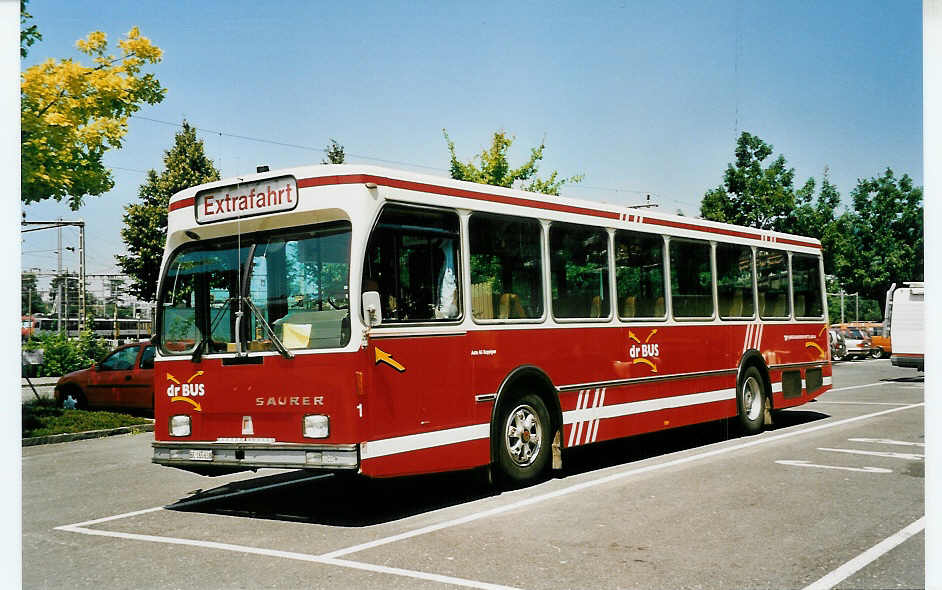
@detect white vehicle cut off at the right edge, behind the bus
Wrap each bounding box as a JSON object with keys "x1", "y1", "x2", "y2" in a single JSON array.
[{"x1": 887, "y1": 283, "x2": 926, "y2": 371}]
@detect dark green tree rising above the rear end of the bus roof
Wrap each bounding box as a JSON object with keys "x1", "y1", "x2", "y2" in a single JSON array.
[{"x1": 700, "y1": 131, "x2": 795, "y2": 230}]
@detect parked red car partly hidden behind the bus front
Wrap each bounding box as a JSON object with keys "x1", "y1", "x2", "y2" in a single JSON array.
[{"x1": 55, "y1": 342, "x2": 154, "y2": 410}]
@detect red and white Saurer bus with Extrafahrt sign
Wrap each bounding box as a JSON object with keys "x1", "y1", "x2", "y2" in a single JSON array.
[{"x1": 153, "y1": 165, "x2": 831, "y2": 484}]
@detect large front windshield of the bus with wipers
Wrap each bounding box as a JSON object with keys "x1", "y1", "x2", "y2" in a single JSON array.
[{"x1": 158, "y1": 222, "x2": 350, "y2": 354}]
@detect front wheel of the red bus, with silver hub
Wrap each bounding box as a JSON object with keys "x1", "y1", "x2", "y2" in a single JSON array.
[{"x1": 497, "y1": 393, "x2": 553, "y2": 487}]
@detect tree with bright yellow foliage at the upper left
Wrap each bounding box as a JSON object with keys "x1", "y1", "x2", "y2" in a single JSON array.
[{"x1": 20, "y1": 27, "x2": 167, "y2": 211}]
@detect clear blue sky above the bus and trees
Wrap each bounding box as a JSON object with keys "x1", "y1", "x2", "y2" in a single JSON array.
[{"x1": 22, "y1": 0, "x2": 923, "y2": 292}]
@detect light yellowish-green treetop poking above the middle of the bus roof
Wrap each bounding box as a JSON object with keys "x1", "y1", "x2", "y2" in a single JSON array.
[{"x1": 442, "y1": 129, "x2": 584, "y2": 195}]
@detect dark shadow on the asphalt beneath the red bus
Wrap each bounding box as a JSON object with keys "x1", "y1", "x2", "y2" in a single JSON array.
[{"x1": 166, "y1": 410, "x2": 828, "y2": 527}]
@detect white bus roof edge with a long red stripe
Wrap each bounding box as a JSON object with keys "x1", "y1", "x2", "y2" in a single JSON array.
[{"x1": 169, "y1": 164, "x2": 821, "y2": 250}]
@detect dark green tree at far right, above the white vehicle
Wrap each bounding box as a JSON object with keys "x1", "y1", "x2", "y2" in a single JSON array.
[{"x1": 834, "y1": 168, "x2": 924, "y2": 301}]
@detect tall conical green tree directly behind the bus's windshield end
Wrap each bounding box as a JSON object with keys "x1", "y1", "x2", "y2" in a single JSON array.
[{"x1": 115, "y1": 121, "x2": 219, "y2": 301}]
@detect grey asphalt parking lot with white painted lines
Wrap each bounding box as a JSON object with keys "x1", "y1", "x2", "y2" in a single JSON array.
[{"x1": 23, "y1": 360, "x2": 925, "y2": 588}]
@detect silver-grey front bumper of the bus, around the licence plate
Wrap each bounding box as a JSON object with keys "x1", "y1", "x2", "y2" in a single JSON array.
[{"x1": 151, "y1": 441, "x2": 360, "y2": 470}]
